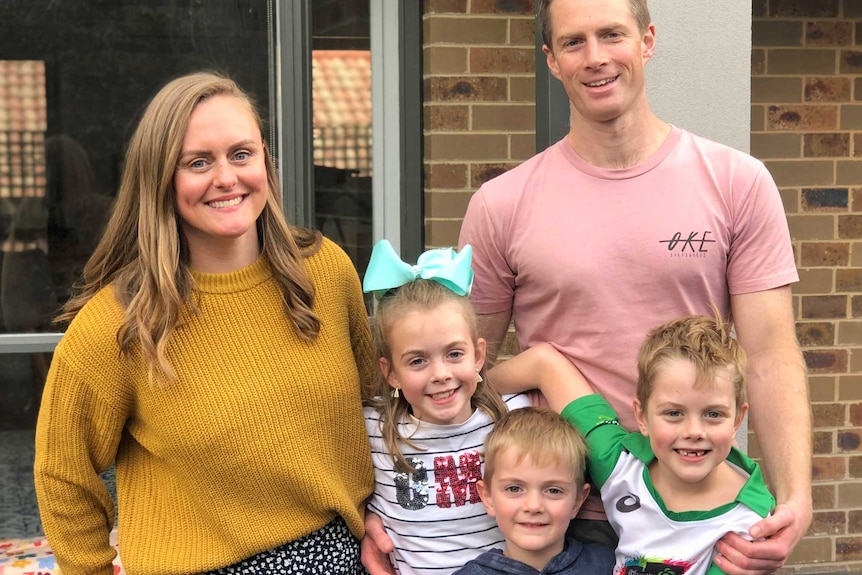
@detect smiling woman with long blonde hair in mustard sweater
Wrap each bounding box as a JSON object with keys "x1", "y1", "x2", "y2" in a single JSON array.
[{"x1": 35, "y1": 73, "x2": 373, "y2": 575}]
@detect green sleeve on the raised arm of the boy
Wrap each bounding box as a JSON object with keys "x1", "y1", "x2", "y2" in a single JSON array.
[{"x1": 561, "y1": 393, "x2": 628, "y2": 487}]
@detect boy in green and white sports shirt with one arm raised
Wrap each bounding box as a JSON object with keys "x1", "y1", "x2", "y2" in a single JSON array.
[{"x1": 489, "y1": 316, "x2": 775, "y2": 575}]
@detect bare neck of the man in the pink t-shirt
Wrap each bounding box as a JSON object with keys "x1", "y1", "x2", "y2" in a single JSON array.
[{"x1": 566, "y1": 110, "x2": 671, "y2": 169}]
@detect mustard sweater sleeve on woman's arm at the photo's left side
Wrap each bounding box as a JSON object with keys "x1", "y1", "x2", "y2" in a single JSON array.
[{"x1": 34, "y1": 342, "x2": 125, "y2": 575}]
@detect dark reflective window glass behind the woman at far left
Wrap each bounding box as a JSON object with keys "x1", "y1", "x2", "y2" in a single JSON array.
[{"x1": 0, "y1": 0, "x2": 277, "y2": 539}]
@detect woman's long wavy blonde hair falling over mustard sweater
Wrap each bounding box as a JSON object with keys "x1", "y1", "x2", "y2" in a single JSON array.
[{"x1": 56, "y1": 73, "x2": 321, "y2": 381}]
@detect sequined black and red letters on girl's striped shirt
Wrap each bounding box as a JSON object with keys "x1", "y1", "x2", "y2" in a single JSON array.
[{"x1": 395, "y1": 449, "x2": 482, "y2": 511}]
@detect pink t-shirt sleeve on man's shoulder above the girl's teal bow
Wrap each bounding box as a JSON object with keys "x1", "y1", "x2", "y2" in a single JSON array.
[{"x1": 458, "y1": 184, "x2": 515, "y2": 314}]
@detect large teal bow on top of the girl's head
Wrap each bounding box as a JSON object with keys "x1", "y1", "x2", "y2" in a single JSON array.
[{"x1": 362, "y1": 240, "x2": 473, "y2": 299}]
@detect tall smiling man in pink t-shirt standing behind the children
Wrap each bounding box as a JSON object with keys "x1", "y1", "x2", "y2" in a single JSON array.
[{"x1": 363, "y1": 0, "x2": 812, "y2": 575}]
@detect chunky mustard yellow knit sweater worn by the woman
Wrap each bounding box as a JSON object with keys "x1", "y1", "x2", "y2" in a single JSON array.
[{"x1": 35, "y1": 240, "x2": 374, "y2": 575}]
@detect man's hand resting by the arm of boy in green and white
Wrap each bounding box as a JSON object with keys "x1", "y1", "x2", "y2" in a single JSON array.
[{"x1": 715, "y1": 502, "x2": 812, "y2": 575}]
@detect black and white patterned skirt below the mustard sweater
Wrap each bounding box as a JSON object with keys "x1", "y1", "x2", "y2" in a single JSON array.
[{"x1": 201, "y1": 517, "x2": 368, "y2": 575}]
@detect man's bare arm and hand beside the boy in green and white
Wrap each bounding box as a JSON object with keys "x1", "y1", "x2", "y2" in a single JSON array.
[{"x1": 716, "y1": 286, "x2": 812, "y2": 575}]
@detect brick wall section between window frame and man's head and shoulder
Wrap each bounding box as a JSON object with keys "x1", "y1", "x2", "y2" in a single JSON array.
[{"x1": 423, "y1": 0, "x2": 536, "y2": 247}]
